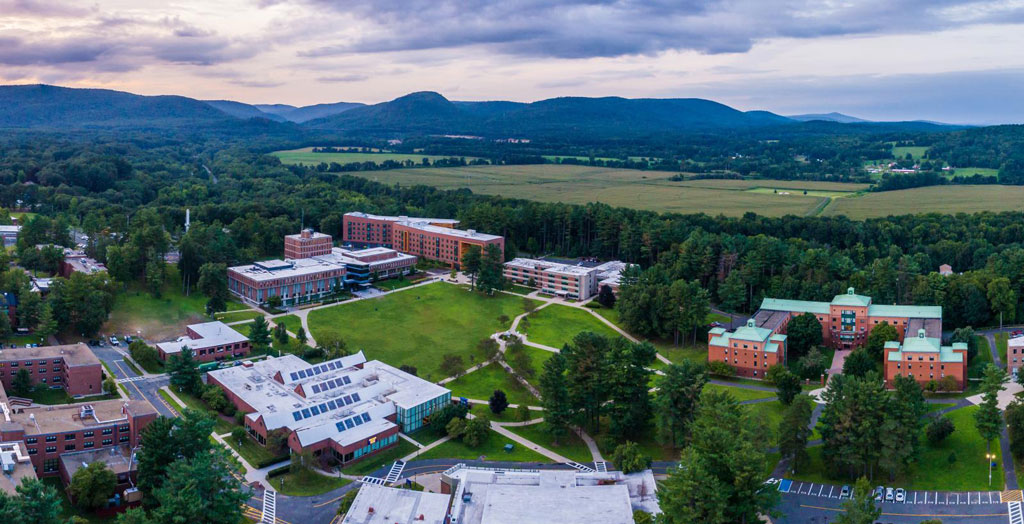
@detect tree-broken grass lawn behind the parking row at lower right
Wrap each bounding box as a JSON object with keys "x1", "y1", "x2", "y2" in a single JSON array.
[{"x1": 793, "y1": 406, "x2": 1004, "y2": 491}]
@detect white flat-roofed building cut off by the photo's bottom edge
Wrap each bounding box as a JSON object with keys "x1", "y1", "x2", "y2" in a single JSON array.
[{"x1": 341, "y1": 464, "x2": 659, "y2": 524}]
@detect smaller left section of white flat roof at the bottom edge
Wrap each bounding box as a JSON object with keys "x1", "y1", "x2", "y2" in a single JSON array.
[{"x1": 341, "y1": 484, "x2": 450, "y2": 524}]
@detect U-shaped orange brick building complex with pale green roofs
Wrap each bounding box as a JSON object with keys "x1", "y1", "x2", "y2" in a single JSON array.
[{"x1": 708, "y1": 288, "x2": 967, "y2": 388}]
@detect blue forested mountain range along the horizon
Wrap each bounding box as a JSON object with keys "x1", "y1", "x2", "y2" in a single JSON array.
[{"x1": 0, "y1": 85, "x2": 958, "y2": 139}]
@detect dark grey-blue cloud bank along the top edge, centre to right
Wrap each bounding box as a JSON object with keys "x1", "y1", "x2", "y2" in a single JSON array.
[{"x1": 290, "y1": 0, "x2": 1024, "y2": 58}]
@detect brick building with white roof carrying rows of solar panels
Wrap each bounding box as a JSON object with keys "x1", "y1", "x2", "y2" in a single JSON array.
[{"x1": 207, "y1": 351, "x2": 452, "y2": 465}]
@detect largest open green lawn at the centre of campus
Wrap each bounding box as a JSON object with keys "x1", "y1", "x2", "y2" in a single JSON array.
[{"x1": 308, "y1": 282, "x2": 540, "y2": 381}]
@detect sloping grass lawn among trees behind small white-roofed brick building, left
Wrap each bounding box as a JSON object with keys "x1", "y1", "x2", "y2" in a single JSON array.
[{"x1": 102, "y1": 265, "x2": 246, "y2": 340}]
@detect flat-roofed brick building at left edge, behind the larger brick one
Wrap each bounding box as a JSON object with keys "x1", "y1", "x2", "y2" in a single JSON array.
[{"x1": 0, "y1": 344, "x2": 103, "y2": 397}]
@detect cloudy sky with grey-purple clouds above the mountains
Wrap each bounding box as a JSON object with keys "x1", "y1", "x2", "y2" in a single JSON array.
[{"x1": 0, "y1": 0, "x2": 1024, "y2": 124}]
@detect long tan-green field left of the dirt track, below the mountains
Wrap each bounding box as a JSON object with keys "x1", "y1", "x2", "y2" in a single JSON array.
[{"x1": 339, "y1": 164, "x2": 867, "y2": 216}]
